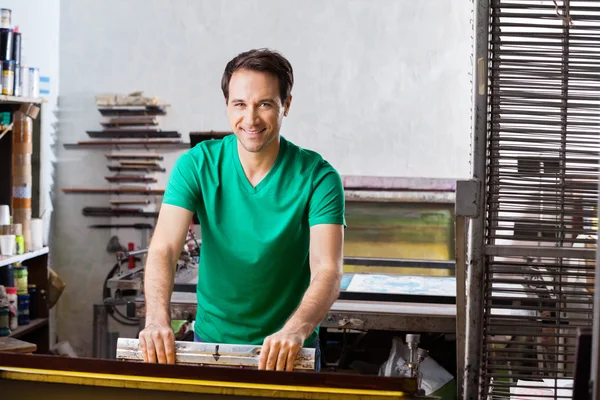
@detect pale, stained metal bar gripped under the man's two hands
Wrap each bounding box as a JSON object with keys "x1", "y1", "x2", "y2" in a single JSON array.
[{"x1": 117, "y1": 338, "x2": 316, "y2": 371}]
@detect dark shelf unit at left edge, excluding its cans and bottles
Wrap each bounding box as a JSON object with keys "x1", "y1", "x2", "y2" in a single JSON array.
[{"x1": 0, "y1": 95, "x2": 50, "y2": 354}]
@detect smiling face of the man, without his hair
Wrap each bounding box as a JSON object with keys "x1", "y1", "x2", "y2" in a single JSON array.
[{"x1": 227, "y1": 69, "x2": 291, "y2": 153}]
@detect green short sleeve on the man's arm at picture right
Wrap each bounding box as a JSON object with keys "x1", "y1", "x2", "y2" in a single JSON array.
[{"x1": 308, "y1": 161, "x2": 346, "y2": 227}]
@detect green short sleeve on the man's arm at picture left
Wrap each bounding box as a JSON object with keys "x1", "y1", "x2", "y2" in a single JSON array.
[{"x1": 162, "y1": 152, "x2": 202, "y2": 212}]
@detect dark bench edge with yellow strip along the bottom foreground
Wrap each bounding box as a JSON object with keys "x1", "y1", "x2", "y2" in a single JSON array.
[{"x1": 0, "y1": 354, "x2": 433, "y2": 400}]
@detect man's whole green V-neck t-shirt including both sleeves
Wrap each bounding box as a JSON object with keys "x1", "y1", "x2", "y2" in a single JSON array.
[{"x1": 163, "y1": 135, "x2": 346, "y2": 344}]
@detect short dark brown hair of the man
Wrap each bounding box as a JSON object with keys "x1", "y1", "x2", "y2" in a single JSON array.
[{"x1": 221, "y1": 49, "x2": 294, "y2": 103}]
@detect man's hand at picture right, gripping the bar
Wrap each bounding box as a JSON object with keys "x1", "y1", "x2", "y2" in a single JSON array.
[{"x1": 258, "y1": 329, "x2": 304, "y2": 371}]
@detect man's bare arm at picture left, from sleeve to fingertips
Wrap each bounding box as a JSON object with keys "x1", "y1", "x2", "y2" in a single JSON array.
[{"x1": 140, "y1": 204, "x2": 193, "y2": 364}]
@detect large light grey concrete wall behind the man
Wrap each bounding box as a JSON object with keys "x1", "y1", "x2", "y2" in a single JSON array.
[{"x1": 53, "y1": 0, "x2": 471, "y2": 354}]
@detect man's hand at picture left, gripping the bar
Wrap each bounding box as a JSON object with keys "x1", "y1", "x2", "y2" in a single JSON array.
[{"x1": 139, "y1": 323, "x2": 175, "y2": 364}]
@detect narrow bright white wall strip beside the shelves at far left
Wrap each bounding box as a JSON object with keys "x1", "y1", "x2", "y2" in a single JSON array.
[{"x1": 2, "y1": 0, "x2": 60, "y2": 344}]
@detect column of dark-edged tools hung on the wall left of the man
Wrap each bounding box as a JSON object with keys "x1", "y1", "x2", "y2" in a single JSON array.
[{"x1": 62, "y1": 92, "x2": 189, "y2": 228}]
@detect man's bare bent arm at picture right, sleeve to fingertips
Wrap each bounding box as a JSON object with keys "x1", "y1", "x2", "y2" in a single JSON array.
[{"x1": 259, "y1": 224, "x2": 344, "y2": 371}]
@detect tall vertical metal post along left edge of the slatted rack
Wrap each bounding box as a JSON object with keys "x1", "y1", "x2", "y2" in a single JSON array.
[{"x1": 463, "y1": 0, "x2": 490, "y2": 400}]
